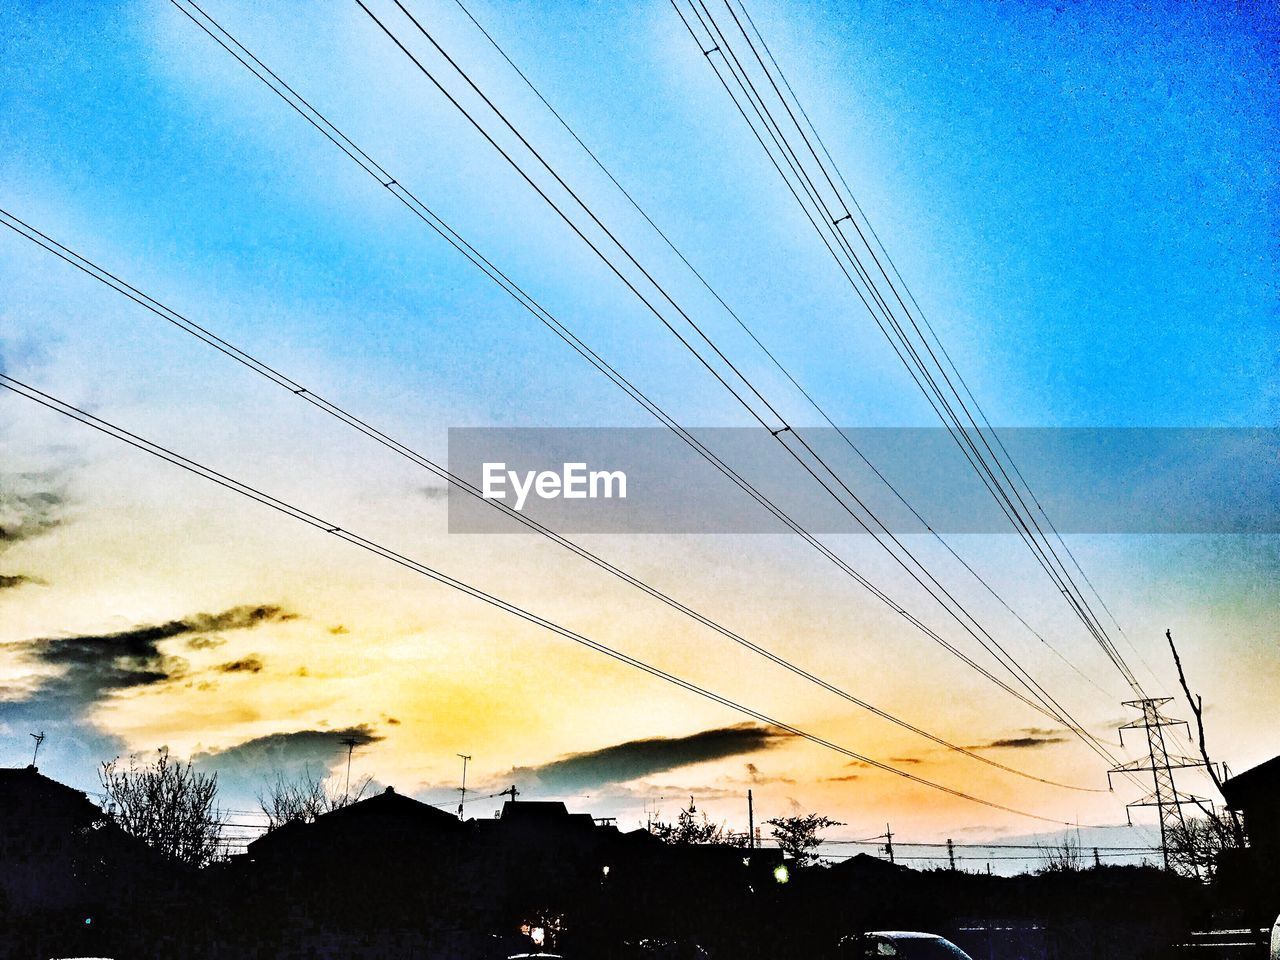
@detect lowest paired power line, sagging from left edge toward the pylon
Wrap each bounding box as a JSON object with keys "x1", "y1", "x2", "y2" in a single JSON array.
[{"x1": 0, "y1": 374, "x2": 1090, "y2": 826}]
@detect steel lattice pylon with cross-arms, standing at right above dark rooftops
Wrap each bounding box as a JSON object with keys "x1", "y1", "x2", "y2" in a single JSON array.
[{"x1": 1107, "y1": 696, "x2": 1212, "y2": 877}]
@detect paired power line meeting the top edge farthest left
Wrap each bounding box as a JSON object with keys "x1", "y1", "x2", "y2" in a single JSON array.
[{"x1": 172, "y1": 0, "x2": 1114, "y2": 762}]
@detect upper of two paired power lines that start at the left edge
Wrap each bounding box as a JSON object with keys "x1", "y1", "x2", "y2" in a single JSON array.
[{"x1": 0, "y1": 209, "x2": 1106, "y2": 792}]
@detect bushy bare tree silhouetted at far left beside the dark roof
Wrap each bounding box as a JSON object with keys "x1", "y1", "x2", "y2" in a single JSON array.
[{"x1": 97, "y1": 749, "x2": 224, "y2": 868}]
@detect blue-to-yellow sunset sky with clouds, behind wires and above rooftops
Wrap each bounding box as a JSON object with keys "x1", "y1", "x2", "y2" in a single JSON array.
[{"x1": 0, "y1": 0, "x2": 1280, "y2": 870}]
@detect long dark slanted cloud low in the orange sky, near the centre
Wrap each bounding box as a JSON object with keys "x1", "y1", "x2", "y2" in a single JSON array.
[{"x1": 501, "y1": 723, "x2": 790, "y2": 794}]
